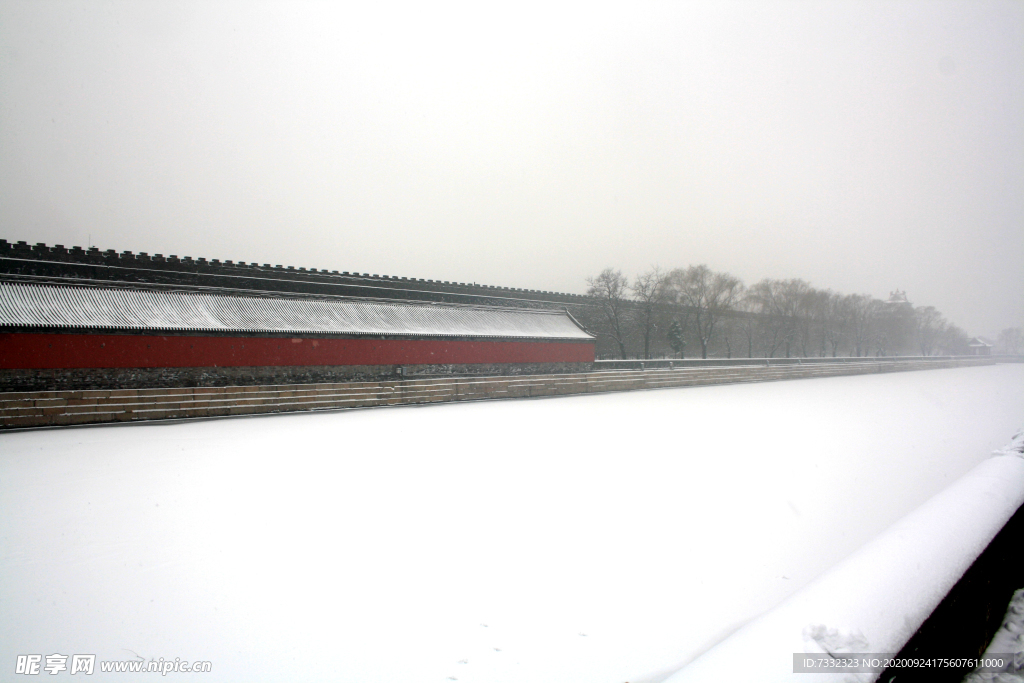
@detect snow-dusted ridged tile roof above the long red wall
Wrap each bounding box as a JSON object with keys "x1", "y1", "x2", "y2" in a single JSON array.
[{"x1": 0, "y1": 284, "x2": 593, "y2": 340}]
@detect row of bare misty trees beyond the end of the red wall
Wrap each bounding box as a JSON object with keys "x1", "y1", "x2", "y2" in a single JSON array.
[{"x1": 585, "y1": 264, "x2": 970, "y2": 358}]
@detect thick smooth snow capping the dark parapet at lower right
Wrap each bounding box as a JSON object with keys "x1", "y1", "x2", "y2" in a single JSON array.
[{"x1": 668, "y1": 440, "x2": 1024, "y2": 683}]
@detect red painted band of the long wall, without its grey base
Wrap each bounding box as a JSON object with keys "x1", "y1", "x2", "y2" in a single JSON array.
[{"x1": 0, "y1": 333, "x2": 594, "y2": 370}]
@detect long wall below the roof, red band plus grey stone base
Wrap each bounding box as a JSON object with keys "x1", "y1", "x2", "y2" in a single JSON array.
[{"x1": 0, "y1": 333, "x2": 594, "y2": 396}]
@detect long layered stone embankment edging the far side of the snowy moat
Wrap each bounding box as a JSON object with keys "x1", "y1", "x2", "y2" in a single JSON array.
[{"x1": 0, "y1": 358, "x2": 991, "y2": 428}]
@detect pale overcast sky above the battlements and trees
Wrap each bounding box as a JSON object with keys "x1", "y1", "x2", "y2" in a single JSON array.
[{"x1": 0, "y1": 0, "x2": 1024, "y2": 335}]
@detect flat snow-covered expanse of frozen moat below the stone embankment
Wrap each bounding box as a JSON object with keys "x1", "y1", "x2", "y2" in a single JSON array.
[{"x1": 6, "y1": 366, "x2": 1024, "y2": 683}]
